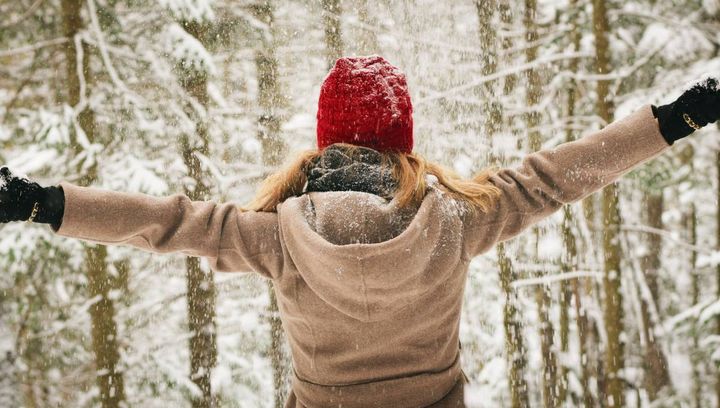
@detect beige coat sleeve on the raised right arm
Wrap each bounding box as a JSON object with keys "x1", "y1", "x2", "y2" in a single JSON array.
[{"x1": 464, "y1": 105, "x2": 670, "y2": 257}]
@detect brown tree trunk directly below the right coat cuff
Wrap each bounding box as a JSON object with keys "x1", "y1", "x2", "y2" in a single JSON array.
[{"x1": 640, "y1": 190, "x2": 670, "y2": 401}]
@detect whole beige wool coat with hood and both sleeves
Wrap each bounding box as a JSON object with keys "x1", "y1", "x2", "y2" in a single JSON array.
[{"x1": 56, "y1": 105, "x2": 669, "y2": 408}]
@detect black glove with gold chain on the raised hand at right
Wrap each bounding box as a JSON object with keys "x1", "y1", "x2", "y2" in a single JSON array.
[{"x1": 652, "y1": 78, "x2": 720, "y2": 145}]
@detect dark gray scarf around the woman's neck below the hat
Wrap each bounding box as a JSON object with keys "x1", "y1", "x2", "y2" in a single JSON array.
[{"x1": 305, "y1": 146, "x2": 397, "y2": 201}]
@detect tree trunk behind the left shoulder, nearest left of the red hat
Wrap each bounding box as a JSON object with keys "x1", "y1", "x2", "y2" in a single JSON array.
[{"x1": 255, "y1": 2, "x2": 290, "y2": 408}]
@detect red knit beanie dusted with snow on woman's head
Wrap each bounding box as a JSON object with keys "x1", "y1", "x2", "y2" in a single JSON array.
[{"x1": 317, "y1": 56, "x2": 413, "y2": 153}]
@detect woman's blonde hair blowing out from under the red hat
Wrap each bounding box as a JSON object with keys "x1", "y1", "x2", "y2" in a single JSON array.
[{"x1": 244, "y1": 143, "x2": 501, "y2": 212}]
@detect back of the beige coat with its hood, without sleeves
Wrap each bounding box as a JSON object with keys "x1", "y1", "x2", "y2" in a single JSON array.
[{"x1": 274, "y1": 188, "x2": 469, "y2": 407}]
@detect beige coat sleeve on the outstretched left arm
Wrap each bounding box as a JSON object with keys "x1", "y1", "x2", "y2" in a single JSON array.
[{"x1": 53, "y1": 181, "x2": 283, "y2": 278}]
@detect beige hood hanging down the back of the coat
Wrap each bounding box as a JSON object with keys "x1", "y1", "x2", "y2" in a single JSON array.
[{"x1": 278, "y1": 187, "x2": 462, "y2": 322}]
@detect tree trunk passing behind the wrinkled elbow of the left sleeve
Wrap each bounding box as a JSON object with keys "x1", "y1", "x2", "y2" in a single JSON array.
[{"x1": 178, "y1": 21, "x2": 217, "y2": 408}]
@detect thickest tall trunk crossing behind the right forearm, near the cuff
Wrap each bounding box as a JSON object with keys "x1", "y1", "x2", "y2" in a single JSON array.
[{"x1": 593, "y1": 0, "x2": 625, "y2": 407}]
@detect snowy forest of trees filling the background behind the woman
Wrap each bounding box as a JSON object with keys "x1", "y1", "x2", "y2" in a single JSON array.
[{"x1": 0, "y1": 0, "x2": 720, "y2": 408}]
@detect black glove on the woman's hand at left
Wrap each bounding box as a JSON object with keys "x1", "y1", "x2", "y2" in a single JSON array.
[{"x1": 0, "y1": 167, "x2": 65, "y2": 231}]
